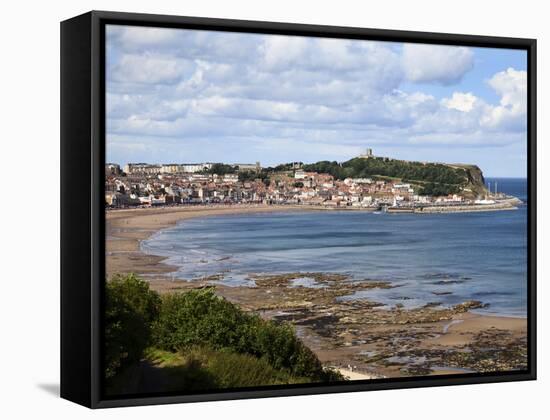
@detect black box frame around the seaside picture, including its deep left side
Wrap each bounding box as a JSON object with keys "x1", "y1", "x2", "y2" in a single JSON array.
[{"x1": 61, "y1": 11, "x2": 536, "y2": 408}]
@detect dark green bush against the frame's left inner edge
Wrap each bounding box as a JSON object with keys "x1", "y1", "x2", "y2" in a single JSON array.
[{"x1": 105, "y1": 274, "x2": 161, "y2": 379}]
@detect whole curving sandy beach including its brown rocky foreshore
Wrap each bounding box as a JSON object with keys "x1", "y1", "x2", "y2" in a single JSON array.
[{"x1": 106, "y1": 205, "x2": 527, "y2": 380}]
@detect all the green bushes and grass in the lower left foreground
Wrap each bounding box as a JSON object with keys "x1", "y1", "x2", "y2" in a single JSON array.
[{"x1": 105, "y1": 275, "x2": 343, "y2": 392}]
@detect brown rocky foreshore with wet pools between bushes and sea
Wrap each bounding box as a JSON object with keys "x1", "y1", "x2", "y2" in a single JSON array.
[{"x1": 208, "y1": 273, "x2": 527, "y2": 377}]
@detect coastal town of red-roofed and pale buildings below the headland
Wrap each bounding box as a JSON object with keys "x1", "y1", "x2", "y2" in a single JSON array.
[{"x1": 105, "y1": 149, "x2": 518, "y2": 212}]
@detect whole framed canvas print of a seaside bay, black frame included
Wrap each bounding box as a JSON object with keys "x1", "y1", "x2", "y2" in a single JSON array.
[{"x1": 61, "y1": 12, "x2": 536, "y2": 408}]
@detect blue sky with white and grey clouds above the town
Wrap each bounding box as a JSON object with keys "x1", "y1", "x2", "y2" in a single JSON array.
[{"x1": 106, "y1": 25, "x2": 527, "y2": 177}]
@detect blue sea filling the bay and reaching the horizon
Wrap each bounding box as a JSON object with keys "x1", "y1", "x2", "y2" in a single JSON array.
[{"x1": 142, "y1": 178, "x2": 527, "y2": 316}]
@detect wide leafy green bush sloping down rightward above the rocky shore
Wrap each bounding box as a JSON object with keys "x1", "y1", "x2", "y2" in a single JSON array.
[{"x1": 154, "y1": 288, "x2": 342, "y2": 381}]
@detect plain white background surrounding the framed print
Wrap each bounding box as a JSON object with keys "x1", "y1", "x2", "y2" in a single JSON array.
[{"x1": 0, "y1": 0, "x2": 550, "y2": 420}]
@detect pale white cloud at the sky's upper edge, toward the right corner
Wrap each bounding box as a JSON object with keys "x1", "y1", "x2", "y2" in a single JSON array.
[{"x1": 402, "y1": 43, "x2": 474, "y2": 85}]
